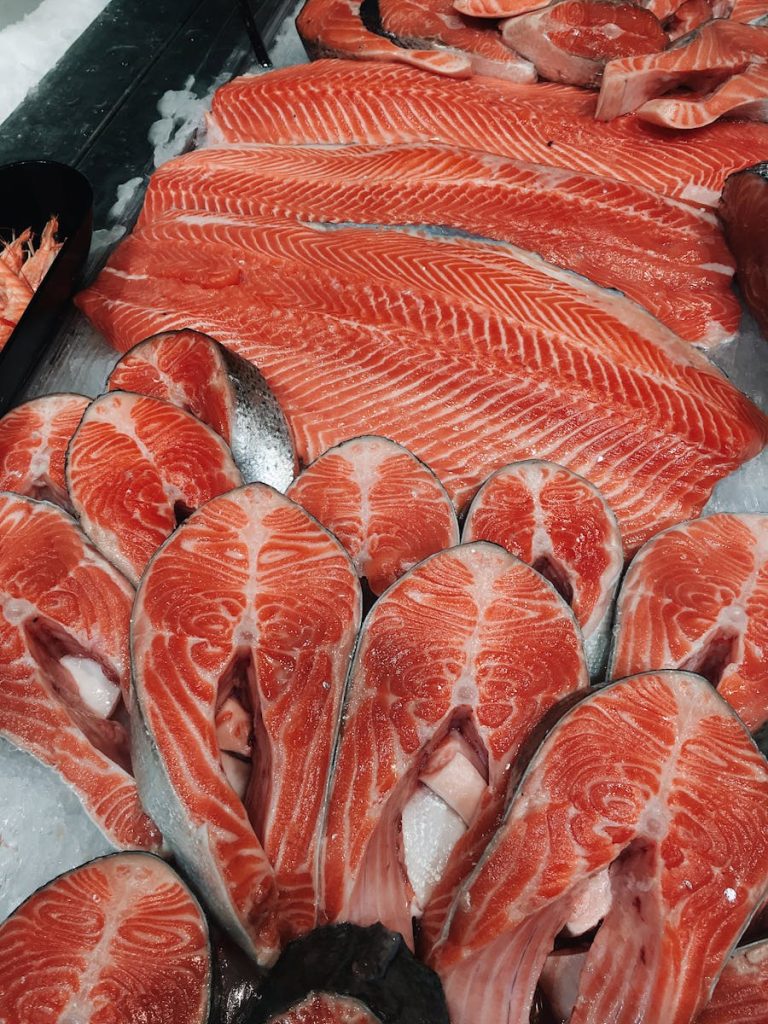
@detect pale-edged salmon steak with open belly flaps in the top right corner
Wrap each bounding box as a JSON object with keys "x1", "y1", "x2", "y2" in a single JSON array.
[{"x1": 595, "y1": 18, "x2": 768, "y2": 125}]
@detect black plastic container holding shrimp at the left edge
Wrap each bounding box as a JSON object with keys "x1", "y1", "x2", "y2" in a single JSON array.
[{"x1": 0, "y1": 160, "x2": 93, "y2": 415}]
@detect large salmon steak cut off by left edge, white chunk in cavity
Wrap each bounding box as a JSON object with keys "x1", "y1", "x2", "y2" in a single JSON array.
[{"x1": 0, "y1": 494, "x2": 160, "y2": 856}]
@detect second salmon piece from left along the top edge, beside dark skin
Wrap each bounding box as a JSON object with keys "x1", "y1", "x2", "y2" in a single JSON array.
[{"x1": 379, "y1": 0, "x2": 537, "y2": 82}]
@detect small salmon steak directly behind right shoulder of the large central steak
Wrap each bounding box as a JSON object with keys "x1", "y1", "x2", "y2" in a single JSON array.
[{"x1": 462, "y1": 461, "x2": 624, "y2": 678}]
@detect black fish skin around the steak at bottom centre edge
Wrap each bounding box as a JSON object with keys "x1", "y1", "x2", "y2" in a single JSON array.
[{"x1": 249, "y1": 924, "x2": 449, "y2": 1024}]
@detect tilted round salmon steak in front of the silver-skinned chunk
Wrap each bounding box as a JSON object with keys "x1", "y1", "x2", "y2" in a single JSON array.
[{"x1": 67, "y1": 391, "x2": 243, "y2": 584}]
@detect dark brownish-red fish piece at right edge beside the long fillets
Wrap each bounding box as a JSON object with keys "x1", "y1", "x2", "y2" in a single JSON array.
[{"x1": 719, "y1": 157, "x2": 768, "y2": 338}]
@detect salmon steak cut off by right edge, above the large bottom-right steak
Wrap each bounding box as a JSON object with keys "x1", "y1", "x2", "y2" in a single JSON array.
[{"x1": 610, "y1": 513, "x2": 768, "y2": 731}]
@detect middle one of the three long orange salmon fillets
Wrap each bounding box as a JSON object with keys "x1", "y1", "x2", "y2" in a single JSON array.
[{"x1": 141, "y1": 144, "x2": 740, "y2": 350}]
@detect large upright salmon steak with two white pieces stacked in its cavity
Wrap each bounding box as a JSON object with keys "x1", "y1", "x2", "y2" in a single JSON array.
[{"x1": 324, "y1": 544, "x2": 588, "y2": 943}]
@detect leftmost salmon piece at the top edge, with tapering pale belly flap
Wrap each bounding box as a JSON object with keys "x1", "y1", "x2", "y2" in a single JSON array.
[{"x1": 296, "y1": 0, "x2": 472, "y2": 78}]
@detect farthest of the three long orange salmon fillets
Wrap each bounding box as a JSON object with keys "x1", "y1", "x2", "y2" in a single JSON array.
[{"x1": 209, "y1": 60, "x2": 768, "y2": 206}]
